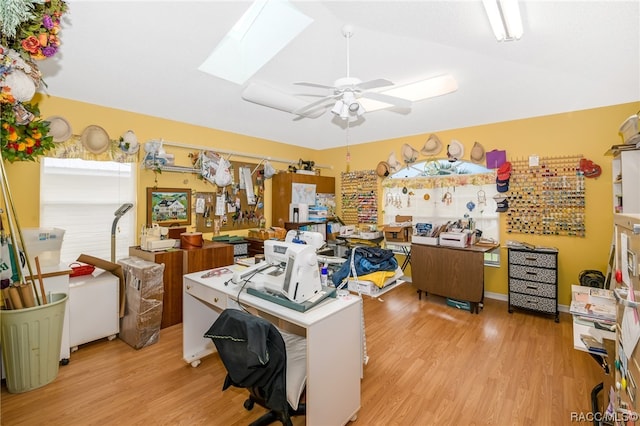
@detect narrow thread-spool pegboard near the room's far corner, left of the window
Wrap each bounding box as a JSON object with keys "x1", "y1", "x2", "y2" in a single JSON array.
[{"x1": 340, "y1": 170, "x2": 378, "y2": 225}]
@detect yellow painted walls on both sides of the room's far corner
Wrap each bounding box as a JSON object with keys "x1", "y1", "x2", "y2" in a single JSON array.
[{"x1": 6, "y1": 97, "x2": 640, "y2": 305}]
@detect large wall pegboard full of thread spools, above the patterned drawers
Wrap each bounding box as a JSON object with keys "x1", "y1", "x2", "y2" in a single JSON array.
[{"x1": 501, "y1": 155, "x2": 586, "y2": 237}]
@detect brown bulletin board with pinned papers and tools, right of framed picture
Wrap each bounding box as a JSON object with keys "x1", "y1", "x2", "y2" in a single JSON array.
[{"x1": 194, "y1": 161, "x2": 265, "y2": 234}]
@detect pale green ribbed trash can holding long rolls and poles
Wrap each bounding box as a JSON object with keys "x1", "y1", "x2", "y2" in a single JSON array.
[{"x1": 0, "y1": 293, "x2": 67, "y2": 393}]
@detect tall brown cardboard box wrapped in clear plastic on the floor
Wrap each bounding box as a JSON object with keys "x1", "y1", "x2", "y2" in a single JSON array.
[{"x1": 118, "y1": 257, "x2": 165, "y2": 349}]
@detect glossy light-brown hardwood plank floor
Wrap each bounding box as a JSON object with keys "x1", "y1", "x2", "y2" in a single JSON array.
[{"x1": 1, "y1": 285, "x2": 603, "y2": 426}]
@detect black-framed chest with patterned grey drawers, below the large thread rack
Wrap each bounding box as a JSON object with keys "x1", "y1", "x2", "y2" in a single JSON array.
[{"x1": 509, "y1": 248, "x2": 560, "y2": 322}]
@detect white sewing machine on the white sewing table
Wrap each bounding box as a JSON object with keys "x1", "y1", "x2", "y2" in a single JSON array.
[{"x1": 232, "y1": 240, "x2": 322, "y2": 303}]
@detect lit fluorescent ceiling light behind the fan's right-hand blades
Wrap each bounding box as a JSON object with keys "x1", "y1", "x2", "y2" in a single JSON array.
[{"x1": 358, "y1": 74, "x2": 458, "y2": 112}]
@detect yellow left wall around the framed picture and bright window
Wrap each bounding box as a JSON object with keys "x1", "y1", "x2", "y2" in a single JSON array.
[{"x1": 6, "y1": 97, "x2": 330, "y2": 238}]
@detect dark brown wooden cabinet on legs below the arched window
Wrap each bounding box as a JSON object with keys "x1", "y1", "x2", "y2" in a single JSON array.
[{"x1": 411, "y1": 244, "x2": 495, "y2": 313}]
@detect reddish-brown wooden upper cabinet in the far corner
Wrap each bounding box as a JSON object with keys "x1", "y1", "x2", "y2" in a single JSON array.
[{"x1": 271, "y1": 173, "x2": 336, "y2": 228}]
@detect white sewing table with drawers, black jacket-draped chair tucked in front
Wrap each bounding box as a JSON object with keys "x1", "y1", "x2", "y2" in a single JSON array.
[{"x1": 183, "y1": 265, "x2": 363, "y2": 426}]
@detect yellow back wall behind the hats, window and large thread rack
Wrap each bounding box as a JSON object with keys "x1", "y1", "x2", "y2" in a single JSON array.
[{"x1": 317, "y1": 102, "x2": 640, "y2": 305}]
